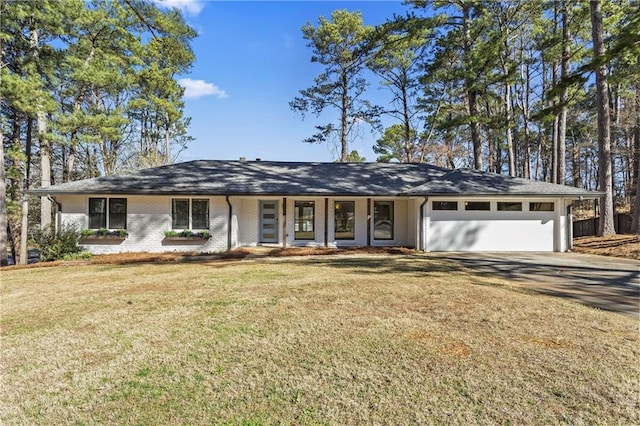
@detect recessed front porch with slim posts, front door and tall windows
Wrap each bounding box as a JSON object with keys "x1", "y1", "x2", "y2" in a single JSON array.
[{"x1": 229, "y1": 196, "x2": 422, "y2": 248}]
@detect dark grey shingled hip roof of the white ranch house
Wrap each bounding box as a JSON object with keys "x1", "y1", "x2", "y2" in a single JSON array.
[{"x1": 29, "y1": 160, "x2": 600, "y2": 197}]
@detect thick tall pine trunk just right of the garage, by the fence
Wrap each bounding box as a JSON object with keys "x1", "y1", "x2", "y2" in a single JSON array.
[{"x1": 589, "y1": 0, "x2": 616, "y2": 236}]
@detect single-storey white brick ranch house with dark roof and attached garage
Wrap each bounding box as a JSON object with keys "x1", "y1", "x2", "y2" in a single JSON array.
[{"x1": 30, "y1": 160, "x2": 601, "y2": 254}]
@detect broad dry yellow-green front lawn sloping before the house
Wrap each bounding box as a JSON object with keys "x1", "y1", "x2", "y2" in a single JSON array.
[{"x1": 0, "y1": 256, "x2": 640, "y2": 425}]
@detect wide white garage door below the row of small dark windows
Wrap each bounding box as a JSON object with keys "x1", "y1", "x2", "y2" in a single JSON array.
[{"x1": 427, "y1": 206, "x2": 555, "y2": 251}]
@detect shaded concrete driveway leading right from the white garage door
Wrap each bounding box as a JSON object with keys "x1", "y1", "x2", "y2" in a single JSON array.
[{"x1": 431, "y1": 253, "x2": 640, "y2": 318}]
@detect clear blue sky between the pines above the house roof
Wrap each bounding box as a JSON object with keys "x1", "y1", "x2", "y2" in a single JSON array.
[{"x1": 156, "y1": 0, "x2": 407, "y2": 161}]
